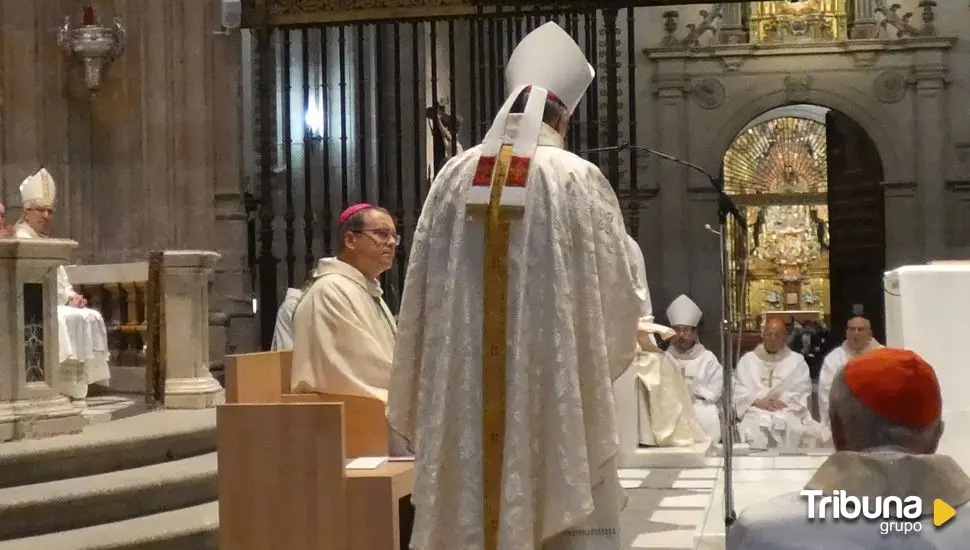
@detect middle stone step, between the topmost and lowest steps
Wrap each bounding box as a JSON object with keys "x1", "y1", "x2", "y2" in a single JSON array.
[{"x1": 0, "y1": 453, "x2": 218, "y2": 540}]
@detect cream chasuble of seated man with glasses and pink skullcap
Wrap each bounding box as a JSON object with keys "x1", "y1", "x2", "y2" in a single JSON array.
[{"x1": 291, "y1": 258, "x2": 397, "y2": 402}]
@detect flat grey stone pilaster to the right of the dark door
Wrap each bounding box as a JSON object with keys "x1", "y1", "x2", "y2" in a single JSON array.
[{"x1": 915, "y1": 59, "x2": 949, "y2": 260}]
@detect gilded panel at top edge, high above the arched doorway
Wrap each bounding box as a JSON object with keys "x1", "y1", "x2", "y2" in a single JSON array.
[{"x1": 748, "y1": 0, "x2": 849, "y2": 43}]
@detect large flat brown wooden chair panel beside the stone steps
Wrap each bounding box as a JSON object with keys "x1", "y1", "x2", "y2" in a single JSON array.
[{"x1": 217, "y1": 403, "x2": 349, "y2": 550}]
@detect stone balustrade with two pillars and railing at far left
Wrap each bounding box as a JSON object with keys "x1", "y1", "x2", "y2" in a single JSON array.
[{"x1": 0, "y1": 246, "x2": 224, "y2": 441}]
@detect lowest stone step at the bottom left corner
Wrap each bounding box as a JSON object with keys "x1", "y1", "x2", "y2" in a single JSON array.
[{"x1": 0, "y1": 502, "x2": 219, "y2": 550}]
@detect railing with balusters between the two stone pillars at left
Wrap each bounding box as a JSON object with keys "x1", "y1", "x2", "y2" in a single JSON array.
[{"x1": 65, "y1": 262, "x2": 150, "y2": 393}]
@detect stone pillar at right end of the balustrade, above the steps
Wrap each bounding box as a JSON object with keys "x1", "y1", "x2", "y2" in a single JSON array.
[{"x1": 160, "y1": 250, "x2": 225, "y2": 409}]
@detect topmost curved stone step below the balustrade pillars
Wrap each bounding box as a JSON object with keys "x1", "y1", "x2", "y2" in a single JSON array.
[{"x1": 0, "y1": 409, "x2": 216, "y2": 489}]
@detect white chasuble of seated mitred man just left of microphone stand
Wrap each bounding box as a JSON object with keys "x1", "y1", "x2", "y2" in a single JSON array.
[{"x1": 667, "y1": 343, "x2": 724, "y2": 443}]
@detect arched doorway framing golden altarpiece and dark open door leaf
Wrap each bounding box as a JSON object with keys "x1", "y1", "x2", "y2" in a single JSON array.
[{"x1": 723, "y1": 105, "x2": 886, "y2": 364}]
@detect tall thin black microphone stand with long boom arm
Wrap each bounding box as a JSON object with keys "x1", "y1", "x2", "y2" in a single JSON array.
[{"x1": 580, "y1": 143, "x2": 748, "y2": 534}]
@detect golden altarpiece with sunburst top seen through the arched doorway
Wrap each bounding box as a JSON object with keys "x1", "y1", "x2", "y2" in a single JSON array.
[{"x1": 724, "y1": 116, "x2": 829, "y2": 330}]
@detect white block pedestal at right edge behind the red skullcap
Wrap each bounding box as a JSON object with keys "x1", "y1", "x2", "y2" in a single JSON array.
[{"x1": 885, "y1": 262, "x2": 970, "y2": 471}]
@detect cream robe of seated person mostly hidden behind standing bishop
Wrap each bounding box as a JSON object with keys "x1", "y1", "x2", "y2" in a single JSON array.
[{"x1": 621, "y1": 237, "x2": 716, "y2": 447}]
